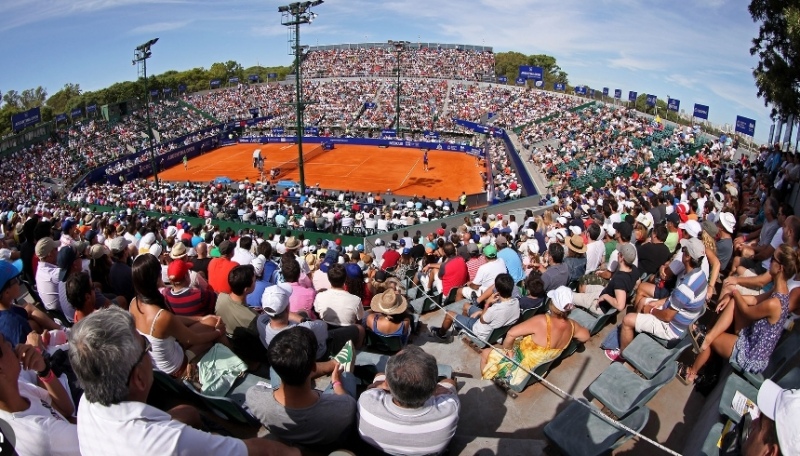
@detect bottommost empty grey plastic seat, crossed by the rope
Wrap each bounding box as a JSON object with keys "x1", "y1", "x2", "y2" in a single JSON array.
[{"x1": 544, "y1": 399, "x2": 650, "y2": 456}]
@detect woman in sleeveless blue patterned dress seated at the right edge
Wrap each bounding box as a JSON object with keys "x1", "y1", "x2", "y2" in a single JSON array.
[{"x1": 678, "y1": 244, "x2": 800, "y2": 384}]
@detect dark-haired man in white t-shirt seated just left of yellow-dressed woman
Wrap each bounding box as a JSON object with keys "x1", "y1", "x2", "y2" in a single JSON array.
[{"x1": 431, "y1": 273, "x2": 520, "y2": 340}]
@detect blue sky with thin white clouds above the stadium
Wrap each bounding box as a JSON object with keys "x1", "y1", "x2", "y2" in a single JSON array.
[{"x1": 0, "y1": 0, "x2": 771, "y2": 141}]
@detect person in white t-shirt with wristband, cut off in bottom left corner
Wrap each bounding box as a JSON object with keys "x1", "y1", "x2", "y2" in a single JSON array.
[{"x1": 0, "y1": 335, "x2": 81, "y2": 456}]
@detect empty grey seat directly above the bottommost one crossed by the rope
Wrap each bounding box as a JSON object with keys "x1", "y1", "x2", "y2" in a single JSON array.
[{"x1": 588, "y1": 363, "x2": 678, "y2": 417}]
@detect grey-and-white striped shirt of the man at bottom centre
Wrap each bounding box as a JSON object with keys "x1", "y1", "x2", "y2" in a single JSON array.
[{"x1": 358, "y1": 383, "x2": 460, "y2": 456}]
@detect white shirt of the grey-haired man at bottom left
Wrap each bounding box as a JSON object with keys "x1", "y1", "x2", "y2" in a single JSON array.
[{"x1": 78, "y1": 396, "x2": 247, "y2": 456}]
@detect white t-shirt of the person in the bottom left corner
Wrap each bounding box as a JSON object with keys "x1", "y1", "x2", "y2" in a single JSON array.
[{"x1": 0, "y1": 380, "x2": 81, "y2": 456}]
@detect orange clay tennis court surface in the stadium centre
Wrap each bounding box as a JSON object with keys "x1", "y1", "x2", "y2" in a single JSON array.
[{"x1": 154, "y1": 143, "x2": 483, "y2": 199}]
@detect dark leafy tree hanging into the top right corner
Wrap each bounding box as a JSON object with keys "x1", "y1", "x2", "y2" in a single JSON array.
[{"x1": 748, "y1": 0, "x2": 800, "y2": 120}]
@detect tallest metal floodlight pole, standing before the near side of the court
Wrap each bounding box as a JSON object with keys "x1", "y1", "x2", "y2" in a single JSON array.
[{"x1": 278, "y1": 0, "x2": 323, "y2": 195}]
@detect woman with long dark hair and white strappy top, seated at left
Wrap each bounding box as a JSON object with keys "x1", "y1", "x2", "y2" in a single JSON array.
[{"x1": 129, "y1": 255, "x2": 230, "y2": 378}]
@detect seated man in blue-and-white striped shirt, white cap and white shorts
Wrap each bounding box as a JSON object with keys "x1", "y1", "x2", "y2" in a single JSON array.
[{"x1": 620, "y1": 238, "x2": 708, "y2": 358}]
